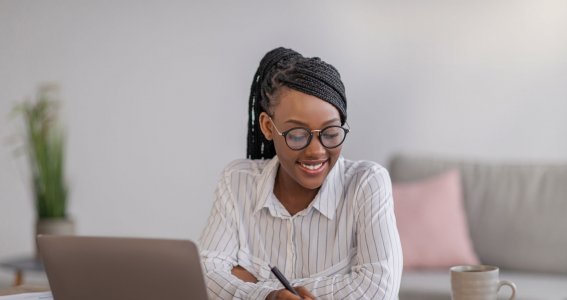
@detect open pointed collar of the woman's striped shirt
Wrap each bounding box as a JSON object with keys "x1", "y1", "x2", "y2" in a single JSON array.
[{"x1": 254, "y1": 155, "x2": 344, "y2": 220}]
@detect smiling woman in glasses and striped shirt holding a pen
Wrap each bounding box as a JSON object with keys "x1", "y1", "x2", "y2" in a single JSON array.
[{"x1": 200, "y1": 48, "x2": 402, "y2": 299}]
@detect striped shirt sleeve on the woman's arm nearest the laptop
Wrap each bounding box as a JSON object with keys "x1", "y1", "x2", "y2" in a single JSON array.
[{"x1": 199, "y1": 169, "x2": 281, "y2": 299}]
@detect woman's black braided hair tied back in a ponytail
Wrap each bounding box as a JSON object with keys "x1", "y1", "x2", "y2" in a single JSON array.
[{"x1": 246, "y1": 47, "x2": 347, "y2": 159}]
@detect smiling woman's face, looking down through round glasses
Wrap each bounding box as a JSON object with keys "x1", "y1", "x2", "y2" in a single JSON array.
[{"x1": 260, "y1": 88, "x2": 342, "y2": 190}]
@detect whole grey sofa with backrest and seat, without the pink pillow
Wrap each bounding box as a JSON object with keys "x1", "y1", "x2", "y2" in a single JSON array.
[{"x1": 389, "y1": 155, "x2": 567, "y2": 300}]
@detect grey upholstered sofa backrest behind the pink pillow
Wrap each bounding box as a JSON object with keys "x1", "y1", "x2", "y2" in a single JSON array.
[{"x1": 389, "y1": 155, "x2": 567, "y2": 274}]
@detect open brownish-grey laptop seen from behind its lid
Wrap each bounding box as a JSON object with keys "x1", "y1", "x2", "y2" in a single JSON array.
[{"x1": 37, "y1": 235, "x2": 211, "y2": 300}]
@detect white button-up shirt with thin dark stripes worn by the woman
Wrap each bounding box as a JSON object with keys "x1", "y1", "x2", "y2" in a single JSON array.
[{"x1": 199, "y1": 156, "x2": 402, "y2": 299}]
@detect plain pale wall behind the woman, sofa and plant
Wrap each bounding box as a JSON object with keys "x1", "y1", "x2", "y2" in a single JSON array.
[{"x1": 0, "y1": 0, "x2": 567, "y2": 286}]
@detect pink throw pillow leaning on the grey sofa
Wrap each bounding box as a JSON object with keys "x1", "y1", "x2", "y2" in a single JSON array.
[{"x1": 393, "y1": 170, "x2": 479, "y2": 269}]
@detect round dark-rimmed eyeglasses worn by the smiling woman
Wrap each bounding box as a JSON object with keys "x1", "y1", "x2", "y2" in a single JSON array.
[{"x1": 270, "y1": 118, "x2": 350, "y2": 151}]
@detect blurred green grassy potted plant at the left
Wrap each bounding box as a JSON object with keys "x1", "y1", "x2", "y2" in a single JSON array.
[{"x1": 16, "y1": 85, "x2": 75, "y2": 258}]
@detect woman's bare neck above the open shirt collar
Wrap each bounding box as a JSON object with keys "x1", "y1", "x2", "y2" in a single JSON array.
[{"x1": 274, "y1": 168, "x2": 319, "y2": 216}]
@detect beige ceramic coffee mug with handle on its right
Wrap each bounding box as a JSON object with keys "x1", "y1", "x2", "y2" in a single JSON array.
[{"x1": 451, "y1": 265, "x2": 516, "y2": 300}]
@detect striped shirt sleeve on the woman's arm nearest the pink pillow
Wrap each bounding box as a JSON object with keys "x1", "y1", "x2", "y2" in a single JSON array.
[{"x1": 292, "y1": 166, "x2": 403, "y2": 299}]
